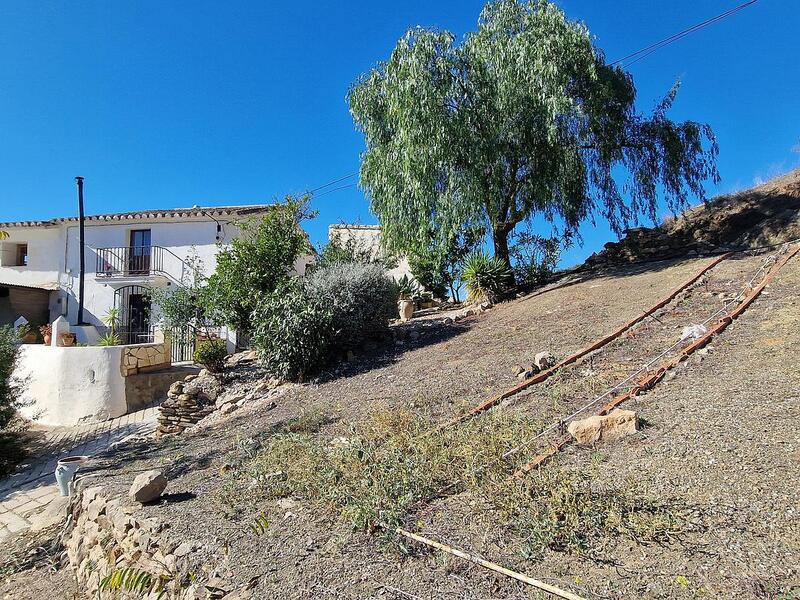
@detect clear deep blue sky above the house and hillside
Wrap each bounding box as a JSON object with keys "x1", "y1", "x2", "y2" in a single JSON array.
[{"x1": 0, "y1": 0, "x2": 800, "y2": 264}]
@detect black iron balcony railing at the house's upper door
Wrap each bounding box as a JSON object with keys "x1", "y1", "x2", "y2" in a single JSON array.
[{"x1": 95, "y1": 246, "x2": 187, "y2": 282}]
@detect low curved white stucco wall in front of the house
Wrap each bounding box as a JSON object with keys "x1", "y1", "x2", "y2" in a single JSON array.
[{"x1": 14, "y1": 344, "x2": 127, "y2": 426}]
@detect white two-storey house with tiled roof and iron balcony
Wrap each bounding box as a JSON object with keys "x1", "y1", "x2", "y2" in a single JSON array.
[{"x1": 0, "y1": 204, "x2": 288, "y2": 356}]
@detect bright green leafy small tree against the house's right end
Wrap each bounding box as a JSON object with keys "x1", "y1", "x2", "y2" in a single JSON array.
[{"x1": 203, "y1": 196, "x2": 313, "y2": 333}]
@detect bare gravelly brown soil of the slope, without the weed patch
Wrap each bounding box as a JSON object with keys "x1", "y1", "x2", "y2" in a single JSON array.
[{"x1": 0, "y1": 251, "x2": 800, "y2": 599}]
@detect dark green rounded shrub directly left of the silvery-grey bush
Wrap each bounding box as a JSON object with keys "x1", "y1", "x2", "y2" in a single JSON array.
[{"x1": 251, "y1": 280, "x2": 333, "y2": 381}]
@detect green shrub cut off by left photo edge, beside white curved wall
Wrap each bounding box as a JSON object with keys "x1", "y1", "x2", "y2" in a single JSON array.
[{"x1": 0, "y1": 327, "x2": 25, "y2": 477}]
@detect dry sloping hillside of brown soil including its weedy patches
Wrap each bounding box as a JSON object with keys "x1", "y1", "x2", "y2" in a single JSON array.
[{"x1": 0, "y1": 172, "x2": 800, "y2": 600}]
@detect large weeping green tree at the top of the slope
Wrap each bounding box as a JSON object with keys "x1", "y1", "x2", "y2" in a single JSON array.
[{"x1": 348, "y1": 0, "x2": 718, "y2": 276}]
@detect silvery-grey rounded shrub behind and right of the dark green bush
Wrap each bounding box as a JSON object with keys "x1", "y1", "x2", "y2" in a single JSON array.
[{"x1": 305, "y1": 263, "x2": 397, "y2": 351}]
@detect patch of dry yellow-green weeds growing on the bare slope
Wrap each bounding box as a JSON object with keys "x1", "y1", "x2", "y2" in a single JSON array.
[{"x1": 224, "y1": 411, "x2": 682, "y2": 557}]
